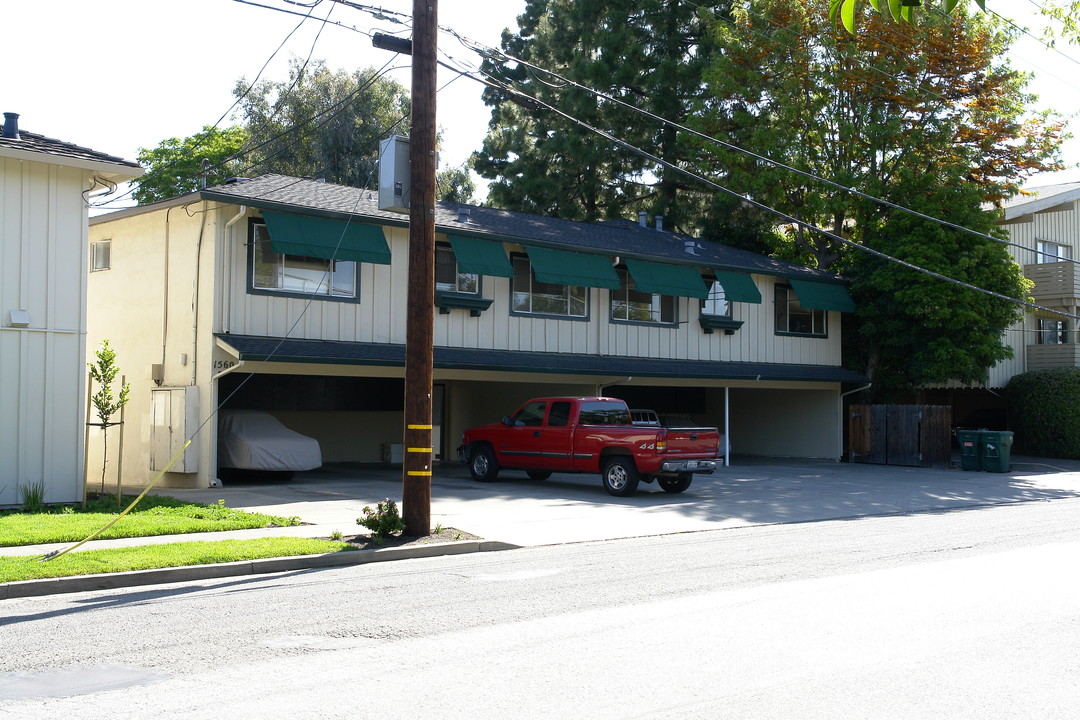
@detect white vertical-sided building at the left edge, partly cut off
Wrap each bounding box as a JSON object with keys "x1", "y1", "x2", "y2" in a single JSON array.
[{"x1": 0, "y1": 112, "x2": 143, "y2": 506}]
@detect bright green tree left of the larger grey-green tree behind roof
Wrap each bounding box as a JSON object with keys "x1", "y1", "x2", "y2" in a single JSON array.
[{"x1": 133, "y1": 125, "x2": 248, "y2": 205}]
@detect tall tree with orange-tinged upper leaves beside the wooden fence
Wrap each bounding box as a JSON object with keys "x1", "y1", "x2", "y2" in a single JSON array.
[{"x1": 698, "y1": 0, "x2": 1062, "y2": 397}]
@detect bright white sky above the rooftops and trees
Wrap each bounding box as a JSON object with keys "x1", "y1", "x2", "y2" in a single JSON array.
[{"x1": 0, "y1": 0, "x2": 1080, "y2": 205}]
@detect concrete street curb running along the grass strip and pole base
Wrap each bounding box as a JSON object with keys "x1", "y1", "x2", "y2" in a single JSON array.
[{"x1": 0, "y1": 540, "x2": 521, "y2": 600}]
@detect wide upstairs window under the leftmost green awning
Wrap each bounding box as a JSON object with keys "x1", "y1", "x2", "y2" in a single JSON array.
[{"x1": 251, "y1": 223, "x2": 356, "y2": 299}]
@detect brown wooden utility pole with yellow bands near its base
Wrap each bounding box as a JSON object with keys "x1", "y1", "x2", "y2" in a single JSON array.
[{"x1": 402, "y1": 0, "x2": 438, "y2": 536}]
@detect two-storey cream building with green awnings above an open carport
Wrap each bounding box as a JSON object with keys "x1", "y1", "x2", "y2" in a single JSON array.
[{"x1": 90, "y1": 175, "x2": 864, "y2": 487}]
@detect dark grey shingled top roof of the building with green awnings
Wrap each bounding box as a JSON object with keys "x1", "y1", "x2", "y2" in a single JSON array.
[{"x1": 201, "y1": 175, "x2": 845, "y2": 283}]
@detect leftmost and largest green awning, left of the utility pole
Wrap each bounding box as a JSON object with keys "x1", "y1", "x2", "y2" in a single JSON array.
[{"x1": 262, "y1": 210, "x2": 390, "y2": 264}]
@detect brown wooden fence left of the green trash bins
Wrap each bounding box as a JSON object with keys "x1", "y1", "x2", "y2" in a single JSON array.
[{"x1": 848, "y1": 405, "x2": 953, "y2": 467}]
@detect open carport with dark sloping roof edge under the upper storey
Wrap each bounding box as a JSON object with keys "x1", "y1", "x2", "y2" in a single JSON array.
[{"x1": 216, "y1": 334, "x2": 863, "y2": 472}]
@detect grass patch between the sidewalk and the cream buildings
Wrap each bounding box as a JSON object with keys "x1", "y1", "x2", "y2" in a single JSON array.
[{"x1": 0, "y1": 495, "x2": 300, "y2": 547}]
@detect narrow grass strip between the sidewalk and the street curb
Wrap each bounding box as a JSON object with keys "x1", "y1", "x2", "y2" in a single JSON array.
[{"x1": 0, "y1": 538, "x2": 356, "y2": 583}]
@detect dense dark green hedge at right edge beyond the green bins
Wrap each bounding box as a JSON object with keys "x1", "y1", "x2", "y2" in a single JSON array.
[{"x1": 1005, "y1": 367, "x2": 1080, "y2": 459}]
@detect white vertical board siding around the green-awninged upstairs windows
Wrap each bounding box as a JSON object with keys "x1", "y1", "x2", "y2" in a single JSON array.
[{"x1": 221, "y1": 222, "x2": 840, "y2": 365}]
